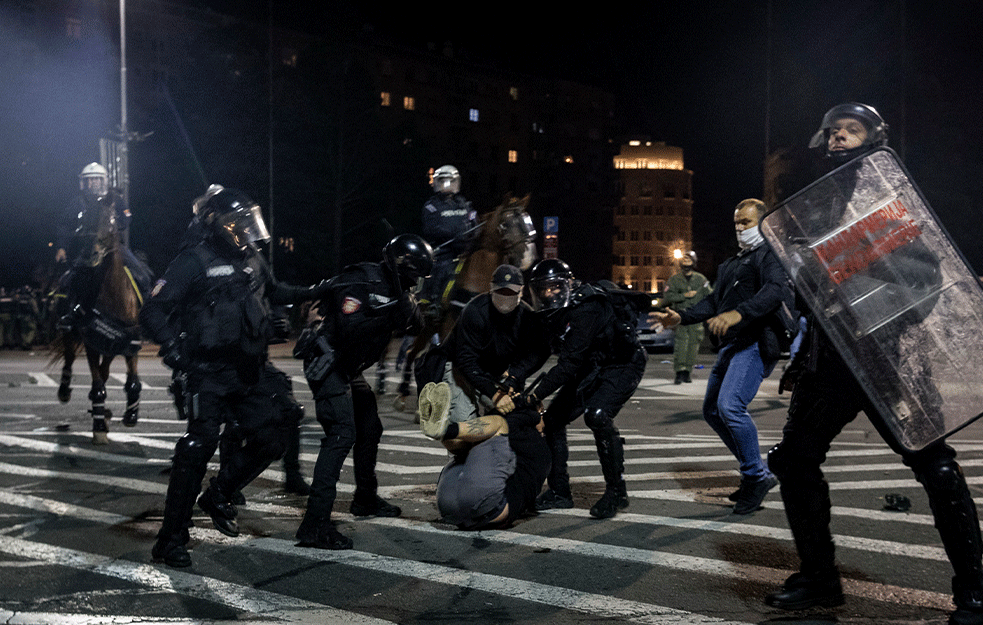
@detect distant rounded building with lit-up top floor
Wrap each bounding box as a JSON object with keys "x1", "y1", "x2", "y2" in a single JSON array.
[{"x1": 611, "y1": 141, "x2": 693, "y2": 293}]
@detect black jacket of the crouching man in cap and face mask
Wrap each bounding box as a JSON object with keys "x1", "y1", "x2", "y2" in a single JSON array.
[{"x1": 445, "y1": 293, "x2": 550, "y2": 397}]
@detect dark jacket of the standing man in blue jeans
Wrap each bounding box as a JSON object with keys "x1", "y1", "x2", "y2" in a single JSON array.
[{"x1": 679, "y1": 242, "x2": 796, "y2": 358}]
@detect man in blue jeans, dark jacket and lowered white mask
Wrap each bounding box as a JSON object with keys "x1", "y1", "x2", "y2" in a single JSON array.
[{"x1": 653, "y1": 199, "x2": 795, "y2": 514}]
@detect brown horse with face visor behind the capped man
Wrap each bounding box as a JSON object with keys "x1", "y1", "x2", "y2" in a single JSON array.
[{"x1": 394, "y1": 195, "x2": 536, "y2": 410}]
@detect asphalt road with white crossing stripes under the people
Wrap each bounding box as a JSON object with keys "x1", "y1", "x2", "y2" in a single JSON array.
[{"x1": 0, "y1": 346, "x2": 983, "y2": 625}]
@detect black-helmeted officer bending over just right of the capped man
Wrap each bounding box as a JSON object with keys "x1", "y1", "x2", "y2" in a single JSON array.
[{"x1": 527, "y1": 259, "x2": 648, "y2": 519}]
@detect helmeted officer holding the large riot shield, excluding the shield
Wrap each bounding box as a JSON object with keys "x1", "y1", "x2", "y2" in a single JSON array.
[{"x1": 765, "y1": 102, "x2": 983, "y2": 625}]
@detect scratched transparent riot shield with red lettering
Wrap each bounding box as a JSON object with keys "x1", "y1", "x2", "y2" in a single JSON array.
[{"x1": 761, "y1": 148, "x2": 983, "y2": 451}]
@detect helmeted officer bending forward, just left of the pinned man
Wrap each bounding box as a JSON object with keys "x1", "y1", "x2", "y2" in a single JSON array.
[{"x1": 294, "y1": 234, "x2": 433, "y2": 549}]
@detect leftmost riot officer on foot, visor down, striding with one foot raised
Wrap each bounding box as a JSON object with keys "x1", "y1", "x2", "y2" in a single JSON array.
[{"x1": 140, "y1": 189, "x2": 325, "y2": 567}]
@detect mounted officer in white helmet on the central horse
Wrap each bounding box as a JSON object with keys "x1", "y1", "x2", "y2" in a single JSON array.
[{"x1": 421, "y1": 165, "x2": 478, "y2": 304}]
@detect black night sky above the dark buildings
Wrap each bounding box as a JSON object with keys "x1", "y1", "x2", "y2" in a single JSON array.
[{"x1": 0, "y1": 0, "x2": 983, "y2": 285}]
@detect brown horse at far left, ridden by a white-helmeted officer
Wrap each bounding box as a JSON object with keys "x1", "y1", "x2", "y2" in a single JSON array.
[{"x1": 52, "y1": 195, "x2": 143, "y2": 445}]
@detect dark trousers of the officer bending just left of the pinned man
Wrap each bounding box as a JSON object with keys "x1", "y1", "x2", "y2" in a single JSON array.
[{"x1": 307, "y1": 372, "x2": 382, "y2": 517}]
